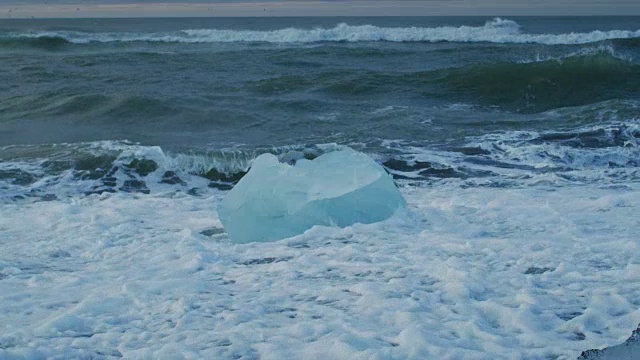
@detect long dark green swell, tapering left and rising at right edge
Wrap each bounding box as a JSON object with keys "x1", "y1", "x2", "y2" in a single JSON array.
[{"x1": 246, "y1": 47, "x2": 640, "y2": 113}]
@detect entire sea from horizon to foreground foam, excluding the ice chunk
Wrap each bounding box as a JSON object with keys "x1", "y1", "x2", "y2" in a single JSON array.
[{"x1": 0, "y1": 17, "x2": 640, "y2": 359}]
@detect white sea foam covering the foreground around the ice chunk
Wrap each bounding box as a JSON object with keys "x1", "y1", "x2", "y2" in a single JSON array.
[{"x1": 0, "y1": 183, "x2": 640, "y2": 359}]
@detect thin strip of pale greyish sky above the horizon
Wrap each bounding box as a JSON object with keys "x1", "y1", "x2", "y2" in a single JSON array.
[{"x1": 0, "y1": 0, "x2": 640, "y2": 19}]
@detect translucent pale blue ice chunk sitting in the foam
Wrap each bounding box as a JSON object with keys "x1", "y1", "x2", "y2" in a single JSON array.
[{"x1": 218, "y1": 148, "x2": 405, "y2": 243}]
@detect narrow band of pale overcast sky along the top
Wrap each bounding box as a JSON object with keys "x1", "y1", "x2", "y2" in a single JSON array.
[{"x1": 0, "y1": 0, "x2": 640, "y2": 20}]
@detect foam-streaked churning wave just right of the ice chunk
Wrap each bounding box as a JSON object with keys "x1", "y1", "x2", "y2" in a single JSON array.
[{"x1": 383, "y1": 119, "x2": 640, "y2": 187}]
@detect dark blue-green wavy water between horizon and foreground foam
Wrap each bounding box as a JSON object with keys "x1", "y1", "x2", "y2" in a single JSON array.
[{"x1": 0, "y1": 17, "x2": 640, "y2": 199}]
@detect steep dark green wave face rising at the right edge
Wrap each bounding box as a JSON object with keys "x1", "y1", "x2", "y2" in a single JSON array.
[{"x1": 436, "y1": 49, "x2": 640, "y2": 113}]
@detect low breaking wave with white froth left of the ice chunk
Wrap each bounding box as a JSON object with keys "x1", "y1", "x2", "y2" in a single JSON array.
[{"x1": 0, "y1": 141, "x2": 342, "y2": 202}]
